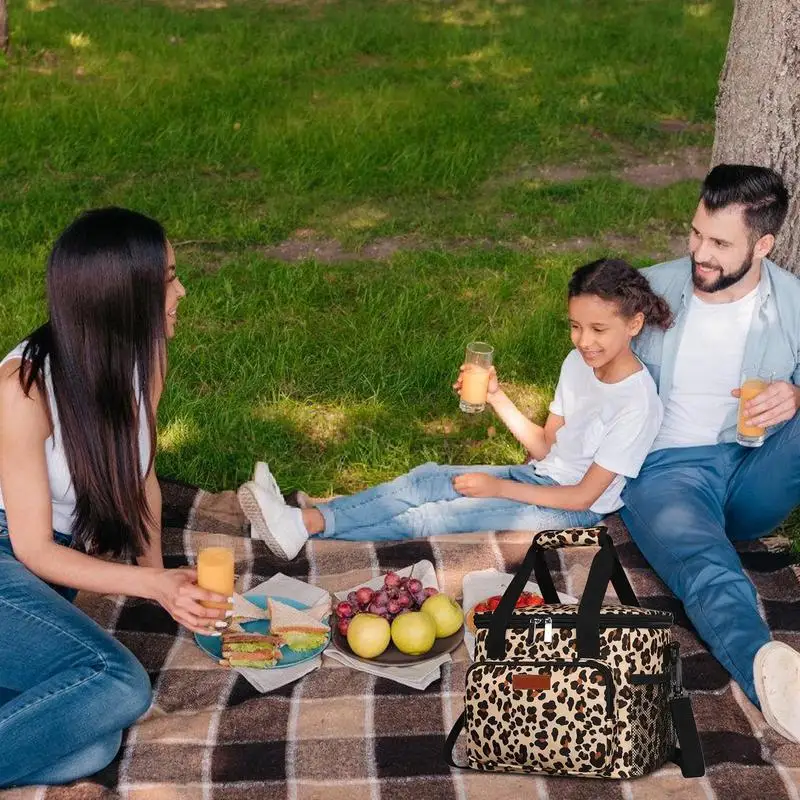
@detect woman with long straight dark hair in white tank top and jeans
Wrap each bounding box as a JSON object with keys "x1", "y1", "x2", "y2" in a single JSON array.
[{"x1": 0, "y1": 208, "x2": 228, "y2": 789}]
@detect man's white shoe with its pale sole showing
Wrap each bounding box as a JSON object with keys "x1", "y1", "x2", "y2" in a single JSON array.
[{"x1": 753, "y1": 641, "x2": 800, "y2": 744}]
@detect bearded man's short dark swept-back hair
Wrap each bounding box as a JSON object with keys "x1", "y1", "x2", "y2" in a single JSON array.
[{"x1": 700, "y1": 164, "x2": 789, "y2": 241}]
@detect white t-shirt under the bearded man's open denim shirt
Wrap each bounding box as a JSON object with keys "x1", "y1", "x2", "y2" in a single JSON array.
[{"x1": 653, "y1": 287, "x2": 758, "y2": 450}]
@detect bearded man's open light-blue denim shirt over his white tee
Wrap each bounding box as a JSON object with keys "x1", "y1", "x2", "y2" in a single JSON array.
[{"x1": 633, "y1": 257, "x2": 800, "y2": 442}]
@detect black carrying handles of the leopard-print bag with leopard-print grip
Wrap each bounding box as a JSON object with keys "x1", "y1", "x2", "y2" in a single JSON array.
[{"x1": 486, "y1": 525, "x2": 639, "y2": 661}]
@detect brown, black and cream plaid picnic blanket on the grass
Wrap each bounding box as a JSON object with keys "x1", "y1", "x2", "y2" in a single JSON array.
[{"x1": 0, "y1": 482, "x2": 800, "y2": 800}]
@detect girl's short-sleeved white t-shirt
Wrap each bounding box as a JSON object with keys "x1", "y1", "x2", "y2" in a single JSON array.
[{"x1": 534, "y1": 350, "x2": 663, "y2": 514}]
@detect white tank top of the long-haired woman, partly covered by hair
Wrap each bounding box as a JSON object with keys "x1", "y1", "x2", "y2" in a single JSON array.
[{"x1": 0, "y1": 342, "x2": 150, "y2": 534}]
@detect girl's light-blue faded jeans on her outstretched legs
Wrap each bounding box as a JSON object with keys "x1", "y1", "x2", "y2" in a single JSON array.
[{"x1": 318, "y1": 463, "x2": 602, "y2": 541}]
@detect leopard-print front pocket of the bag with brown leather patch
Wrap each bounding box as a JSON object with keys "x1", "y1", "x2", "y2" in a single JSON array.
[{"x1": 466, "y1": 659, "x2": 615, "y2": 775}]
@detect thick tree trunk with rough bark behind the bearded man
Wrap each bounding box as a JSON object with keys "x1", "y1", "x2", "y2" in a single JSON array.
[{"x1": 711, "y1": 0, "x2": 800, "y2": 273}]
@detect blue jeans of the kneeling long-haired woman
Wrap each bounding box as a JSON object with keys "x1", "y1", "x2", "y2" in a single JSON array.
[{"x1": 0, "y1": 511, "x2": 151, "y2": 789}]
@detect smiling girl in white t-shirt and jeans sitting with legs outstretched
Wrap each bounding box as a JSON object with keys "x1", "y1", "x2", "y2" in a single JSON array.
[{"x1": 239, "y1": 259, "x2": 671, "y2": 559}]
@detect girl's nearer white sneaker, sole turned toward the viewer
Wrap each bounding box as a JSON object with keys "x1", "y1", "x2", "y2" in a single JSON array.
[{"x1": 236, "y1": 481, "x2": 308, "y2": 561}]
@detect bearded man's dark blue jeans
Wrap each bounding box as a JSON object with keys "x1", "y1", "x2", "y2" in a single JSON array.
[{"x1": 622, "y1": 415, "x2": 800, "y2": 705}]
